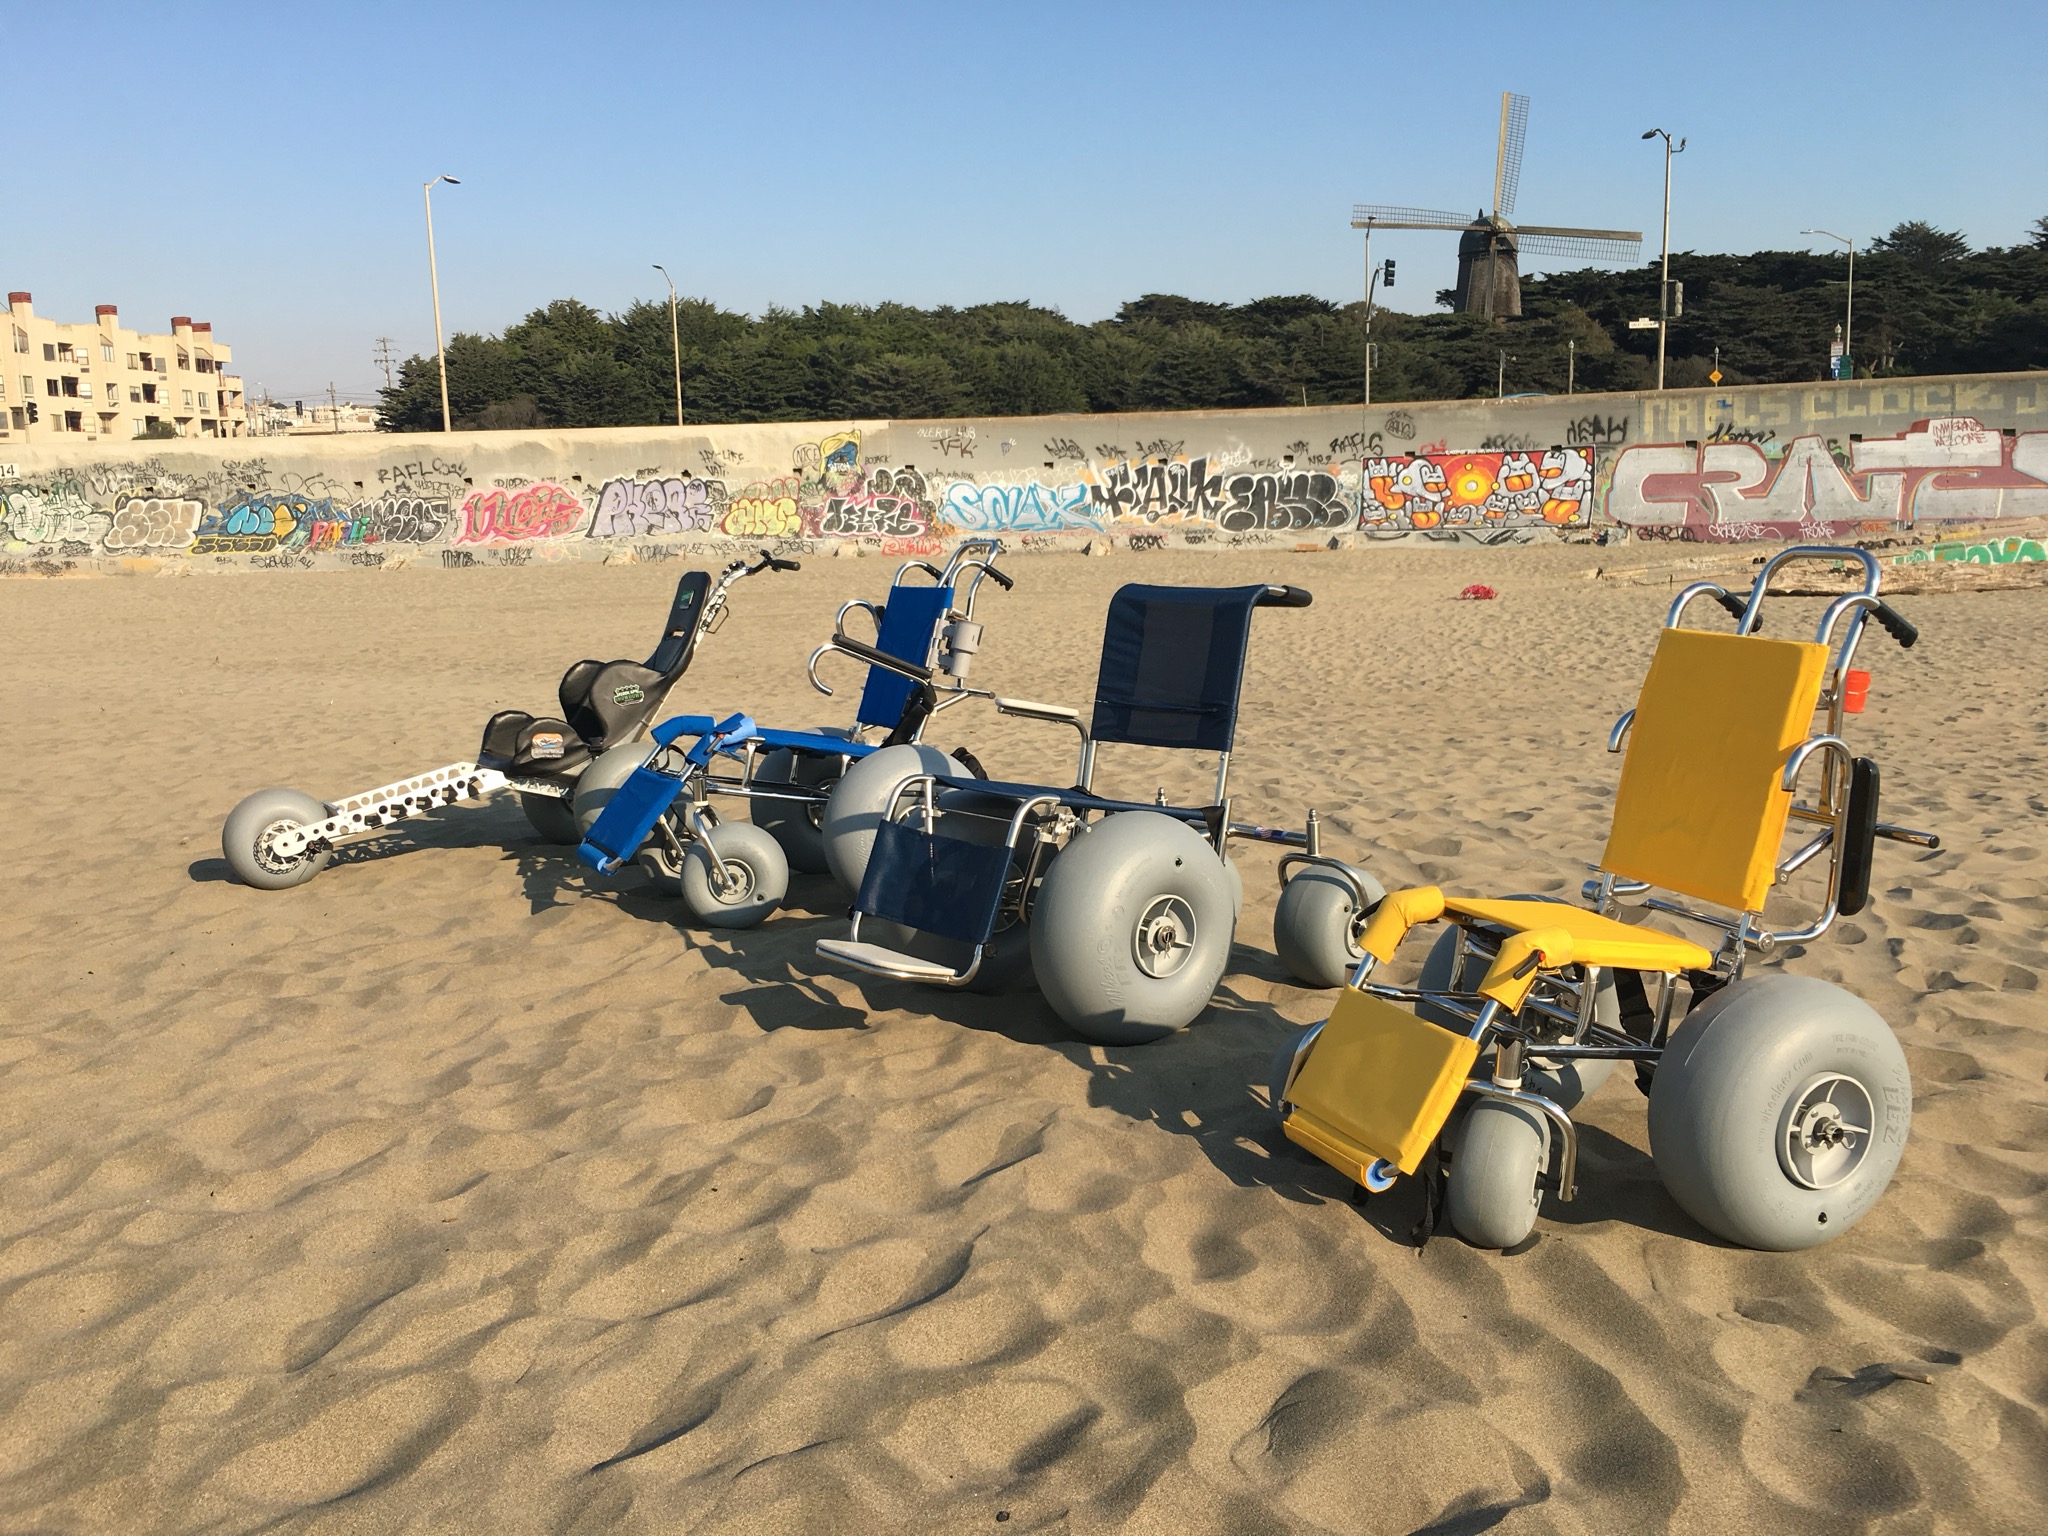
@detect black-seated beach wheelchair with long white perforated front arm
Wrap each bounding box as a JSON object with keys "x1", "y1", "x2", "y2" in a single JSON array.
[{"x1": 221, "y1": 553, "x2": 733, "y2": 891}]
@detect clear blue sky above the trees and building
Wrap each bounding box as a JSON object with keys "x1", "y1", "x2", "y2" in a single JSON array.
[{"x1": 0, "y1": 0, "x2": 2048, "y2": 399}]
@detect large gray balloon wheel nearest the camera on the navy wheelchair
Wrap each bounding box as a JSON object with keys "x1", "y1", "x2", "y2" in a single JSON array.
[{"x1": 1030, "y1": 811, "x2": 1237, "y2": 1044}]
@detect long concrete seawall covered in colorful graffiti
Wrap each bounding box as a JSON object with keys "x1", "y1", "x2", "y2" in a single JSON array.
[{"x1": 0, "y1": 373, "x2": 2048, "y2": 575}]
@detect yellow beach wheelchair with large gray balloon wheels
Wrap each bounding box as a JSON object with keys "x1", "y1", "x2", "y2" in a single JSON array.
[{"x1": 1272, "y1": 547, "x2": 1939, "y2": 1249}]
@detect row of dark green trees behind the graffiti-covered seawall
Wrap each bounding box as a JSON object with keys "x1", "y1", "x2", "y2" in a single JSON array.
[{"x1": 379, "y1": 217, "x2": 2048, "y2": 432}]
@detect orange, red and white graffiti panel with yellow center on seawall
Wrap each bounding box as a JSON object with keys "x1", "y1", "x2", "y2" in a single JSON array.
[{"x1": 1358, "y1": 449, "x2": 1593, "y2": 532}]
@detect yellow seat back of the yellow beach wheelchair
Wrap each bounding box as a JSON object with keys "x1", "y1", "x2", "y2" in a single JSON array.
[{"x1": 1599, "y1": 629, "x2": 1827, "y2": 911}]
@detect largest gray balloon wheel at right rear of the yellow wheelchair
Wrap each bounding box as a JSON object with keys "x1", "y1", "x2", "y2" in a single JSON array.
[{"x1": 1649, "y1": 975, "x2": 1913, "y2": 1251}]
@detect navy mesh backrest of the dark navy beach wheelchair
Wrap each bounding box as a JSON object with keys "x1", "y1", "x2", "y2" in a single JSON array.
[{"x1": 1090, "y1": 586, "x2": 1266, "y2": 752}]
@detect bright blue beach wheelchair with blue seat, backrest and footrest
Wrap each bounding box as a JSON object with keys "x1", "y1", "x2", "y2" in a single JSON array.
[{"x1": 575, "y1": 539, "x2": 1014, "y2": 928}]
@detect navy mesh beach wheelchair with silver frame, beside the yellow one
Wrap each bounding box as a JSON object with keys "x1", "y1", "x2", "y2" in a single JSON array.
[{"x1": 817, "y1": 586, "x2": 1311, "y2": 1044}]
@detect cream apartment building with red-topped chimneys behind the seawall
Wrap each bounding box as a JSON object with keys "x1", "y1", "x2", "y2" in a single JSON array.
[{"x1": 0, "y1": 293, "x2": 246, "y2": 444}]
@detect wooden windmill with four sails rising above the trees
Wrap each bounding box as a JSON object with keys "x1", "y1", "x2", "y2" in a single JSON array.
[{"x1": 1352, "y1": 90, "x2": 1642, "y2": 319}]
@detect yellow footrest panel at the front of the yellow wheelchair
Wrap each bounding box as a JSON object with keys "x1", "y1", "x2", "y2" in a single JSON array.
[{"x1": 1282, "y1": 987, "x2": 1479, "y2": 1184}]
